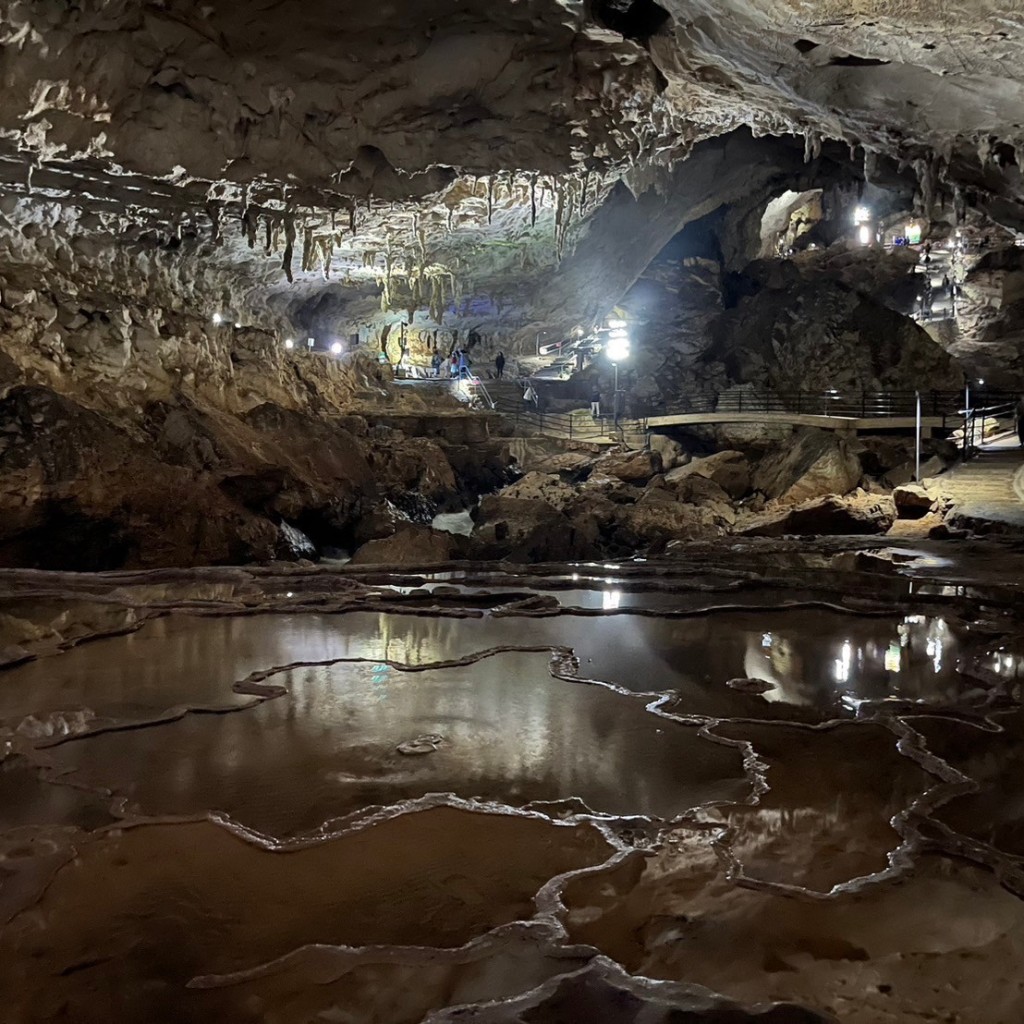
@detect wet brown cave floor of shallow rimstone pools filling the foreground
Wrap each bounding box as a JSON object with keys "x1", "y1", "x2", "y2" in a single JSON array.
[{"x1": 0, "y1": 540, "x2": 1024, "y2": 1024}]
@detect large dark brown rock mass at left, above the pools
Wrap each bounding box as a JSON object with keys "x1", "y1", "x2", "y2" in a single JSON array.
[{"x1": 0, "y1": 376, "x2": 468, "y2": 569}]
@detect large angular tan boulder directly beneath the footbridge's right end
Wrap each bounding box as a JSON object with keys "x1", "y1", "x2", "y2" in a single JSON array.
[{"x1": 754, "y1": 429, "x2": 863, "y2": 505}]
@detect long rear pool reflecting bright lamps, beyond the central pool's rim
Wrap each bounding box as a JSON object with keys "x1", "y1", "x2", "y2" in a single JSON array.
[{"x1": 0, "y1": 602, "x2": 991, "y2": 733}]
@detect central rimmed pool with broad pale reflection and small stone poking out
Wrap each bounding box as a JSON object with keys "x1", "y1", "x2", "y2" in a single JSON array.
[{"x1": 51, "y1": 652, "x2": 749, "y2": 837}]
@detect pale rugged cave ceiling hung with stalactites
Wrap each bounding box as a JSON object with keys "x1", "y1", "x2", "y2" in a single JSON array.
[{"x1": 0, "y1": 0, "x2": 1024, "y2": 342}]
